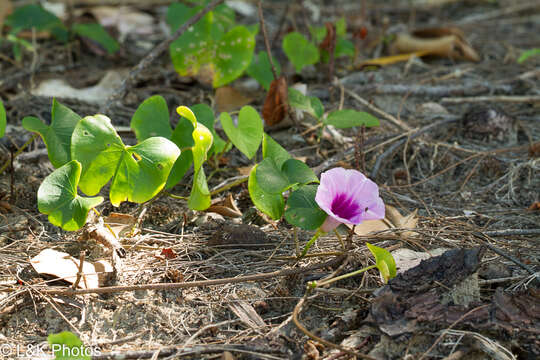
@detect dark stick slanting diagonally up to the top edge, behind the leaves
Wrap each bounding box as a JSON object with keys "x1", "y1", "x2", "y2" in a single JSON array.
[{"x1": 99, "y1": 0, "x2": 225, "y2": 113}]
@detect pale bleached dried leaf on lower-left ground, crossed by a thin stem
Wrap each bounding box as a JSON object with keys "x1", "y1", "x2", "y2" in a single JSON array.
[{"x1": 30, "y1": 249, "x2": 99, "y2": 289}]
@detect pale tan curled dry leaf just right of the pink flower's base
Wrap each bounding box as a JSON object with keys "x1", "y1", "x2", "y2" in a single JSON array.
[{"x1": 347, "y1": 205, "x2": 418, "y2": 239}]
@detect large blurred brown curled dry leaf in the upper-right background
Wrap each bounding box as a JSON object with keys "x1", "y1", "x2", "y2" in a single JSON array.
[{"x1": 390, "y1": 27, "x2": 480, "y2": 62}]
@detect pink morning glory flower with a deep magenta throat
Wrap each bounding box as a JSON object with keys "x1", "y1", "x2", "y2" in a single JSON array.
[{"x1": 315, "y1": 168, "x2": 384, "y2": 232}]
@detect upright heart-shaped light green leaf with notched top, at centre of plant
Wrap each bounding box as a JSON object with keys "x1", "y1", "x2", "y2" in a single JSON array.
[{"x1": 219, "y1": 106, "x2": 263, "y2": 159}]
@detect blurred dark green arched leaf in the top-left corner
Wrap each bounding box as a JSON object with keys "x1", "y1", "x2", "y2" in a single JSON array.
[{"x1": 5, "y1": 4, "x2": 69, "y2": 42}]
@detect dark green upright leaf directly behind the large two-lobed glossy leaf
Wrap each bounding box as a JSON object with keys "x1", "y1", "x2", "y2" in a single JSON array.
[{"x1": 131, "y1": 95, "x2": 171, "y2": 141}]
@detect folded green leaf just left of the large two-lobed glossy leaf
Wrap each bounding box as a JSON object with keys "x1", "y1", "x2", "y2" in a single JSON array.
[{"x1": 22, "y1": 99, "x2": 81, "y2": 168}]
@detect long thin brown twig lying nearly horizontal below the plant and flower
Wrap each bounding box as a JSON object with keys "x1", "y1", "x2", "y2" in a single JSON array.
[{"x1": 16, "y1": 256, "x2": 342, "y2": 296}]
